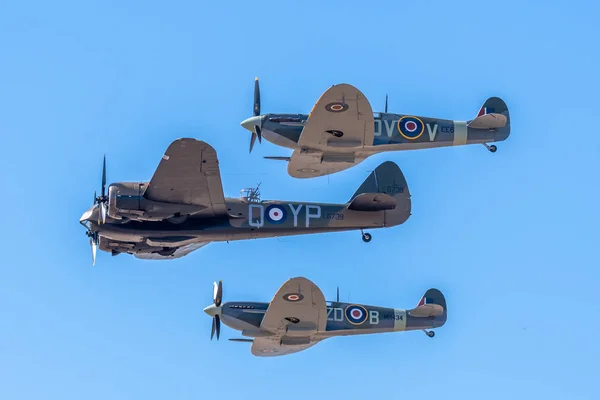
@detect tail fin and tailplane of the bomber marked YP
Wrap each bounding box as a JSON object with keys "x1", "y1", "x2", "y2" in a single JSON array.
[{"x1": 348, "y1": 161, "x2": 411, "y2": 226}]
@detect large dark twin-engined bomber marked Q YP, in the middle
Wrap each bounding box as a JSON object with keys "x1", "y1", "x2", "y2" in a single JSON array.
[{"x1": 79, "y1": 138, "x2": 411, "y2": 265}]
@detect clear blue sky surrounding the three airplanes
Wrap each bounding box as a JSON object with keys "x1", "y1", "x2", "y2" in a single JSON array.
[{"x1": 0, "y1": 0, "x2": 600, "y2": 400}]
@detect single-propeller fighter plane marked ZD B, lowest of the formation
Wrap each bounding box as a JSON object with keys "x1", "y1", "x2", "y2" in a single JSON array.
[{"x1": 204, "y1": 277, "x2": 448, "y2": 357}]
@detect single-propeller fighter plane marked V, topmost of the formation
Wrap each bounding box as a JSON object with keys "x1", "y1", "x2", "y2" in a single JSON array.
[{"x1": 241, "y1": 78, "x2": 510, "y2": 178}]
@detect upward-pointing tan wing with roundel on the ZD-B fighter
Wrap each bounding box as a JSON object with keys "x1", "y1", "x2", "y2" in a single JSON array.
[{"x1": 260, "y1": 277, "x2": 327, "y2": 335}]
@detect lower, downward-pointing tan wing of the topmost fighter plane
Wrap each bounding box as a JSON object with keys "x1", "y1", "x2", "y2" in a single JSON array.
[{"x1": 288, "y1": 150, "x2": 365, "y2": 178}]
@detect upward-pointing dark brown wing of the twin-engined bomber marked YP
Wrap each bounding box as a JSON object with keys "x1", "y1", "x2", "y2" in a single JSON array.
[{"x1": 144, "y1": 138, "x2": 227, "y2": 216}]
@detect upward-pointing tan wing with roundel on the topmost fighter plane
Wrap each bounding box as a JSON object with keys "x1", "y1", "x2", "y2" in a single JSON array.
[{"x1": 298, "y1": 84, "x2": 375, "y2": 149}]
